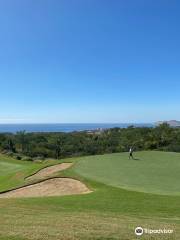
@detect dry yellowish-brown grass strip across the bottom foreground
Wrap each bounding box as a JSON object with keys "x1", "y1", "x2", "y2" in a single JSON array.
[{"x1": 0, "y1": 207, "x2": 180, "y2": 240}]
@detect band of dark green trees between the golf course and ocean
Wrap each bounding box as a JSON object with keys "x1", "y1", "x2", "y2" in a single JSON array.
[{"x1": 0, "y1": 123, "x2": 180, "y2": 160}]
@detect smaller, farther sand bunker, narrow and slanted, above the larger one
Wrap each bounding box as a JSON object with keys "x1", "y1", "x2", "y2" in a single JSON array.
[{"x1": 26, "y1": 163, "x2": 73, "y2": 181}]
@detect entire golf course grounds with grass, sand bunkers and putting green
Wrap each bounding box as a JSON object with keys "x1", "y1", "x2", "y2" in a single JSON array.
[{"x1": 0, "y1": 151, "x2": 180, "y2": 240}]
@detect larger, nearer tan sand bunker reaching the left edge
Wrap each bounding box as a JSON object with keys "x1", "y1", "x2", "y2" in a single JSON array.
[{"x1": 0, "y1": 178, "x2": 91, "y2": 198}]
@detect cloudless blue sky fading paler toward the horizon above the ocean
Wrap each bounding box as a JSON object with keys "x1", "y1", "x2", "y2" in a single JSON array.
[{"x1": 0, "y1": 0, "x2": 180, "y2": 123}]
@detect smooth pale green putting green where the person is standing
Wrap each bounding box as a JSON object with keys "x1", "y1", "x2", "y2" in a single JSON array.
[{"x1": 75, "y1": 151, "x2": 180, "y2": 195}]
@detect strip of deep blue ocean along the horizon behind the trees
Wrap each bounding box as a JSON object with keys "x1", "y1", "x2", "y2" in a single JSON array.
[{"x1": 0, "y1": 123, "x2": 153, "y2": 133}]
